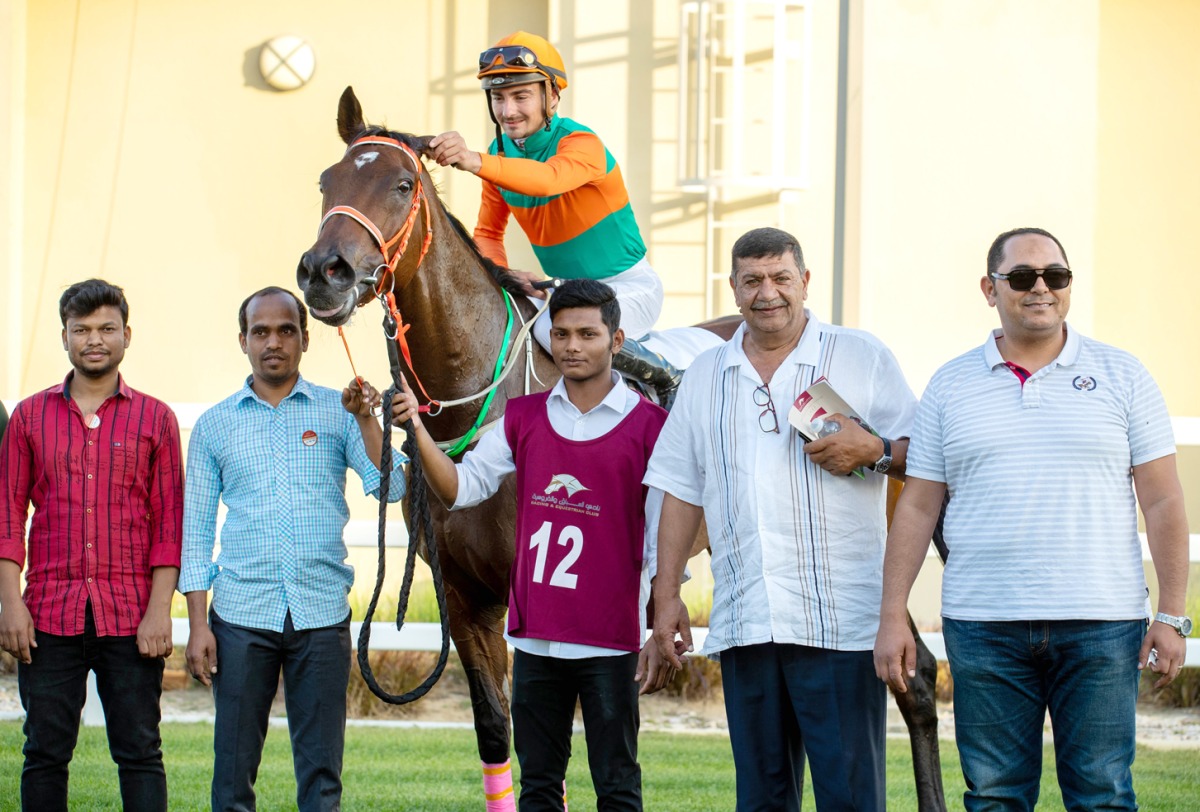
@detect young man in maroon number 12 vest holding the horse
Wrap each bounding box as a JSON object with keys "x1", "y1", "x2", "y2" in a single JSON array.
[{"x1": 392, "y1": 279, "x2": 672, "y2": 812}]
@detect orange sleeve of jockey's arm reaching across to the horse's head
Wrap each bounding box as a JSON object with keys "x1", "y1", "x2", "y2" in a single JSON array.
[{"x1": 475, "y1": 132, "x2": 608, "y2": 198}]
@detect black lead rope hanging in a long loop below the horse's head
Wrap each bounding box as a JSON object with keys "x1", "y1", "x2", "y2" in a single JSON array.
[{"x1": 359, "y1": 333, "x2": 450, "y2": 705}]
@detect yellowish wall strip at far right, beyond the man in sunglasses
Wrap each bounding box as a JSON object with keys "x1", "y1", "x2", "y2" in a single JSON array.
[{"x1": 1094, "y1": 0, "x2": 1200, "y2": 414}]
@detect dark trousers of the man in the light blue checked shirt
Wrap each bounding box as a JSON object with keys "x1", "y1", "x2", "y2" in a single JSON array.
[{"x1": 209, "y1": 612, "x2": 350, "y2": 812}]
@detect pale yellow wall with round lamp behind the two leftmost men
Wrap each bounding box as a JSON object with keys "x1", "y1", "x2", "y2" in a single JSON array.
[{"x1": 7, "y1": 0, "x2": 501, "y2": 402}]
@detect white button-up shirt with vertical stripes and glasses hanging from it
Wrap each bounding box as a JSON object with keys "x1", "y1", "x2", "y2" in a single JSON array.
[{"x1": 644, "y1": 311, "x2": 917, "y2": 654}]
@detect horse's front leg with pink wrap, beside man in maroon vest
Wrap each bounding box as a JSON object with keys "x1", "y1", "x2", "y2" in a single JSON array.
[{"x1": 446, "y1": 589, "x2": 516, "y2": 812}]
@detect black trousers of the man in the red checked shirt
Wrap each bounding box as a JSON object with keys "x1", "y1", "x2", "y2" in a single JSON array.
[{"x1": 17, "y1": 603, "x2": 167, "y2": 812}]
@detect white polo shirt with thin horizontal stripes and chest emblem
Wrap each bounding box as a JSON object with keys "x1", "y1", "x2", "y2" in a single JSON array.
[{"x1": 907, "y1": 327, "x2": 1175, "y2": 620}]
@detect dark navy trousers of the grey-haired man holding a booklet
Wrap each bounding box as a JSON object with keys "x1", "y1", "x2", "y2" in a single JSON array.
[{"x1": 721, "y1": 643, "x2": 888, "y2": 812}]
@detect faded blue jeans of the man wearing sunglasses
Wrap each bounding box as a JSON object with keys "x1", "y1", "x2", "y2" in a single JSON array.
[{"x1": 943, "y1": 618, "x2": 1146, "y2": 812}]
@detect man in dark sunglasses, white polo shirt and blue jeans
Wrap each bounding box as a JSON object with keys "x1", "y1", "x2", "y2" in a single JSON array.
[{"x1": 875, "y1": 228, "x2": 1192, "y2": 810}]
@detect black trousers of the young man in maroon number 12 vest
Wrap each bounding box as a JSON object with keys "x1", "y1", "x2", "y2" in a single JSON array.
[{"x1": 511, "y1": 651, "x2": 642, "y2": 812}]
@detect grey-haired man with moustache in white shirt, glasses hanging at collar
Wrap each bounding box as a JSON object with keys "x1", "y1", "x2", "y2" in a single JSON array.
[{"x1": 644, "y1": 228, "x2": 917, "y2": 811}]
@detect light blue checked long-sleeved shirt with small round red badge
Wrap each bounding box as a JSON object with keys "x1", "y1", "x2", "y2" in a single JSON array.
[{"x1": 179, "y1": 378, "x2": 406, "y2": 632}]
